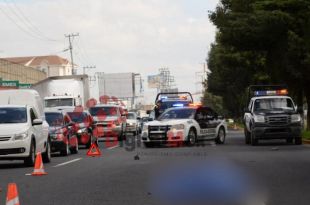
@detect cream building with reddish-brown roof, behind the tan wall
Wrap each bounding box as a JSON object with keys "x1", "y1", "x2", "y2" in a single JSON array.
[{"x1": 4, "y1": 55, "x2": 74, "y2": 77}]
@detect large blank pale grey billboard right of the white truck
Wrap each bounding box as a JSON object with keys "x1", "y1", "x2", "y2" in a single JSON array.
[{"x1": 98, "y1": 73, "x2": 135, "y2": 99}]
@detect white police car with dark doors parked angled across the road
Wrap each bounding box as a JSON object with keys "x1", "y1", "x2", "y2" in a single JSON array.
[{"x1": 141, "y1": 106, "x2": 227, "y2": 147}]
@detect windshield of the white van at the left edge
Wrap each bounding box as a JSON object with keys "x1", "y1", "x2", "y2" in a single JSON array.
[{"x1": 0, "y1": 107, "x2": 27, "y2": 124}]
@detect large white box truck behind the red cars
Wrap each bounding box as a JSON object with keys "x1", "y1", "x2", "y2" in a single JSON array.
[{"x1": 32, "y1": 75, "x2": 89, "y2": 109}]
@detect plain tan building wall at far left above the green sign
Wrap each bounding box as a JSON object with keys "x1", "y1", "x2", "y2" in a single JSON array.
[{"x1": 0, "y1": 59, "x2": 47, "y2": 84}]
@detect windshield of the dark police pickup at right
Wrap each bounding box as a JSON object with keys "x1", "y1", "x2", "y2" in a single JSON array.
[{"x1": 254, "y1": 98, "x2": 294, "y2": 112}]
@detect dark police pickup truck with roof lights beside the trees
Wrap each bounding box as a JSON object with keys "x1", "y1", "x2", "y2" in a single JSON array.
[{"x1": 244, "y1": 86, "x2": 302, "y2": 145}]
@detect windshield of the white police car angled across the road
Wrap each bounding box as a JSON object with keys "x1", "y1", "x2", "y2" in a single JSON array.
[{"x1": 158, "y1": 108, "x2": 196, "y2": 120}]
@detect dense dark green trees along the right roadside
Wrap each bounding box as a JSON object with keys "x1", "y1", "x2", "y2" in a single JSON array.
[{"x1": 204, "y1": 0, "x2": 310, "y2": 130}]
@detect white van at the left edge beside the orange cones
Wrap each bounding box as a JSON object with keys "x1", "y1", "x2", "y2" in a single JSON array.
[{"x1": 0, "y1": 90, "x2": 51, "y2": 166}]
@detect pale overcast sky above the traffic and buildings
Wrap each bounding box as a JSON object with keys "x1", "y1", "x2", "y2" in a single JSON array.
[{"x1": 0, "y1": 0, "x2": 218, "y2": 102}]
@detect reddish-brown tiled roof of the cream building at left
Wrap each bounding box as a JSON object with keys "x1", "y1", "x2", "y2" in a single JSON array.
[{"x1": 3, "y1": 55, "x2": 70, "y2": 67}]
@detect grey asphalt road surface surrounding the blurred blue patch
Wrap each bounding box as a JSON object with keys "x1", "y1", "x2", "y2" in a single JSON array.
[{"x1": 0, "y1": 132, "x2": 310, "y2": 205}]
